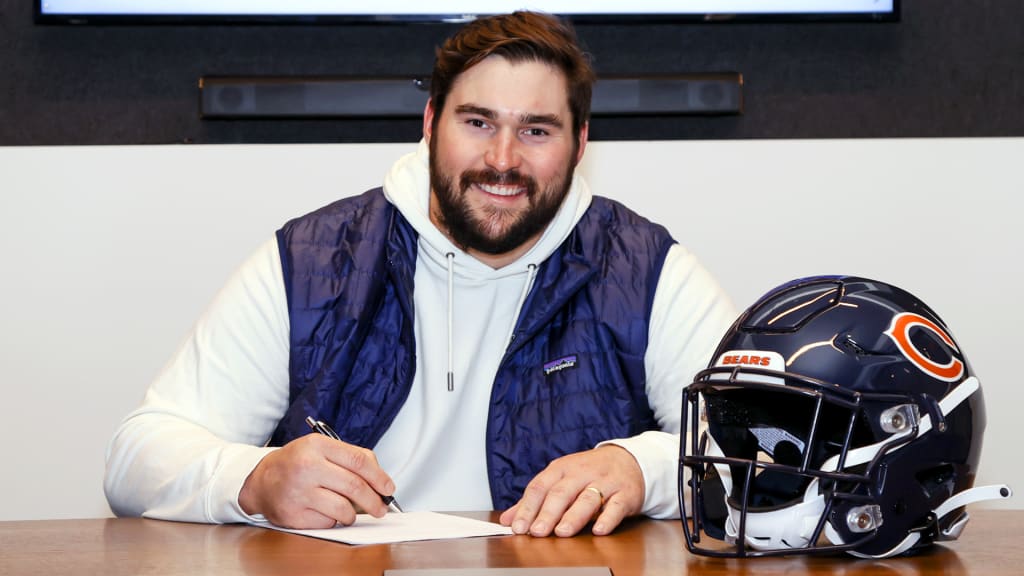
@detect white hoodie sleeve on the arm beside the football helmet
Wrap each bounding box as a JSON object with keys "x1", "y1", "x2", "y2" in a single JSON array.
[{"x1": 598, "y1": 244, "x2": 736, "y2": 519}]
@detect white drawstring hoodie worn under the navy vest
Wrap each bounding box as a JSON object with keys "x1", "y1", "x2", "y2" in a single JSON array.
[{"x1": 104, "y1": 141, "x2": 734, "y2": 522}]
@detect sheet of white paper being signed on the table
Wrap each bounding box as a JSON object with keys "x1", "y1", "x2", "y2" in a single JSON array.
[{"x1": 253, "y1": 511, "x2": 512, "y2": 544}]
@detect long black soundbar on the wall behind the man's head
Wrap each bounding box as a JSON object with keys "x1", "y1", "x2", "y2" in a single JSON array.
[{"x1": 199, "y1": 73, "x2": 743, "y2": 119}]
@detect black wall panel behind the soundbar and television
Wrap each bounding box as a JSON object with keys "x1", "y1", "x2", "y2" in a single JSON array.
[{"x1": 0, "y1": 0, "x2": 1024, "y2": 146}]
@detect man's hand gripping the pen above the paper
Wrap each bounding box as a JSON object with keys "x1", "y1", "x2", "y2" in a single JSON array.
[{"x1": 239, "y1": 434, "x2": 394, "y2": 530}]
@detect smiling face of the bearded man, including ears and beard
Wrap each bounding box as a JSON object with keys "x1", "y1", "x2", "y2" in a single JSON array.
[{"x1": 424, "y1": 56, "x2": 587, "y2": 265}]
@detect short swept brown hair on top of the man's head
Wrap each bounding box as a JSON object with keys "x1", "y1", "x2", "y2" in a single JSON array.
[{"x1": 430, "y1": 11, "x2": 595, "y2": 138}]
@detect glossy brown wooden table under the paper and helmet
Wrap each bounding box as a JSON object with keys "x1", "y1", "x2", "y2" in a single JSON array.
[{"x1": 0, "y1": 510, "x2": 1024, "y2": 576}]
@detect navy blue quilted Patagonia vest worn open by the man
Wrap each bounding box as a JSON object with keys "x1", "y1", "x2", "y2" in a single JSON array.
[{"x1": 270, "y1": 189, "x2": 673, "y2": 509}]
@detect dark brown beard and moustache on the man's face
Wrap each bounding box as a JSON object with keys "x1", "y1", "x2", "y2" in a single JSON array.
[{"x1": 430, "y1": 138, "x2": 575, "y2": 255}]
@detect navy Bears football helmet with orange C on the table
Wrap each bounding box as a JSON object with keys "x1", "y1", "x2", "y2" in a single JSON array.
[{"x1": 679, "y1": 276, "x2": 1011, "y2": 558}]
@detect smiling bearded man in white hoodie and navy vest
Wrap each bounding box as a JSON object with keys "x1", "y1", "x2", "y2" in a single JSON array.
[{"x1": 104, "y1": 12, "x2": 734, "y2": 536}]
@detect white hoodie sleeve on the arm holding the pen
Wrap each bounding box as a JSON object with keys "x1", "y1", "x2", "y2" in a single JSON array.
[{"x1": 103, "y1": 239, "x2": 289, "y2": 523}]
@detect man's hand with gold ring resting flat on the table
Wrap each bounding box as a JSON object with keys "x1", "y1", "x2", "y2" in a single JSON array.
[{"x1": 499, "y1": 444, "x2": 644, "y2": 536}]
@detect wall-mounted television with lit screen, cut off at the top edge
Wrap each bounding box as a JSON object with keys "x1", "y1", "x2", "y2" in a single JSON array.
[{"x1": 35, "y1": 0, "x2": 900, "y2": 24}]
